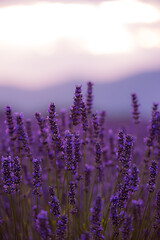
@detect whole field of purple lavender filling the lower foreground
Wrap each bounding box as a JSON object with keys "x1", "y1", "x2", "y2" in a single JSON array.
[{"x1": 0, "y1": 82, "x2": 160, "y2": 240}]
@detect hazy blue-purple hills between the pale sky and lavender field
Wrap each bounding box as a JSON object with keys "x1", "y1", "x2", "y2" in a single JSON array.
[{"x1": 0, "y1": 71, "x2": 160, "y2": 117}]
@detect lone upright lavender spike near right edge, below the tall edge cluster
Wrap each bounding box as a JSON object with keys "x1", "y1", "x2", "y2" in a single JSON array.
[{"x1": 147, "y1": 161, "x2": 157, "y2": 193}]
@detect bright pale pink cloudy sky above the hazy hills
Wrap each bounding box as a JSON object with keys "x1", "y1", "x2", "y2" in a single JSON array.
[{"x1": 0, "y1": 0, "x2": 160, "y2": 89}]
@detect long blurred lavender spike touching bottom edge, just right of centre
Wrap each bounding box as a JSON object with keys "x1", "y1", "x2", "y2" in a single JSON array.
[{"x1": 90, "y1": 196, "x2": 104, "y2": 240}]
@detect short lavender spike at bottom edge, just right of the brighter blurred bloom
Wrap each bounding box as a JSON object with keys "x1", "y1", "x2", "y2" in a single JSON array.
[{"x1": 56, "y1": 215, "x2": 68, "y2": 240}]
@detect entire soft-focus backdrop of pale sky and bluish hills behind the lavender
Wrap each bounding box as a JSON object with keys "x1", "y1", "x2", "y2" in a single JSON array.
[{"x1": 0, "y1": 0, "x2": 160, "y2": 118}]
